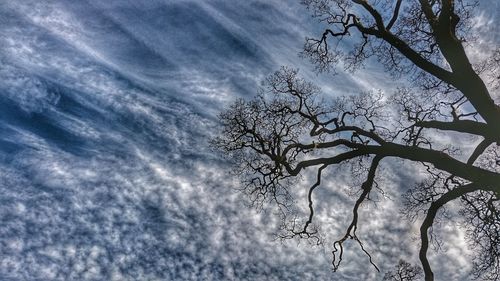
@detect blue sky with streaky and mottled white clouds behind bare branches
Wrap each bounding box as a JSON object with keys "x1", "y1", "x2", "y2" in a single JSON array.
[{"x1": 0, "y1": 0, "x2": 498, "y2": 280}]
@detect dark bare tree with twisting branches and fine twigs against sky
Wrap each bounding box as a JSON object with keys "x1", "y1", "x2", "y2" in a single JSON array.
[{"x1": 214, "y1": 0, "x2": 500, "y2": 280}]
